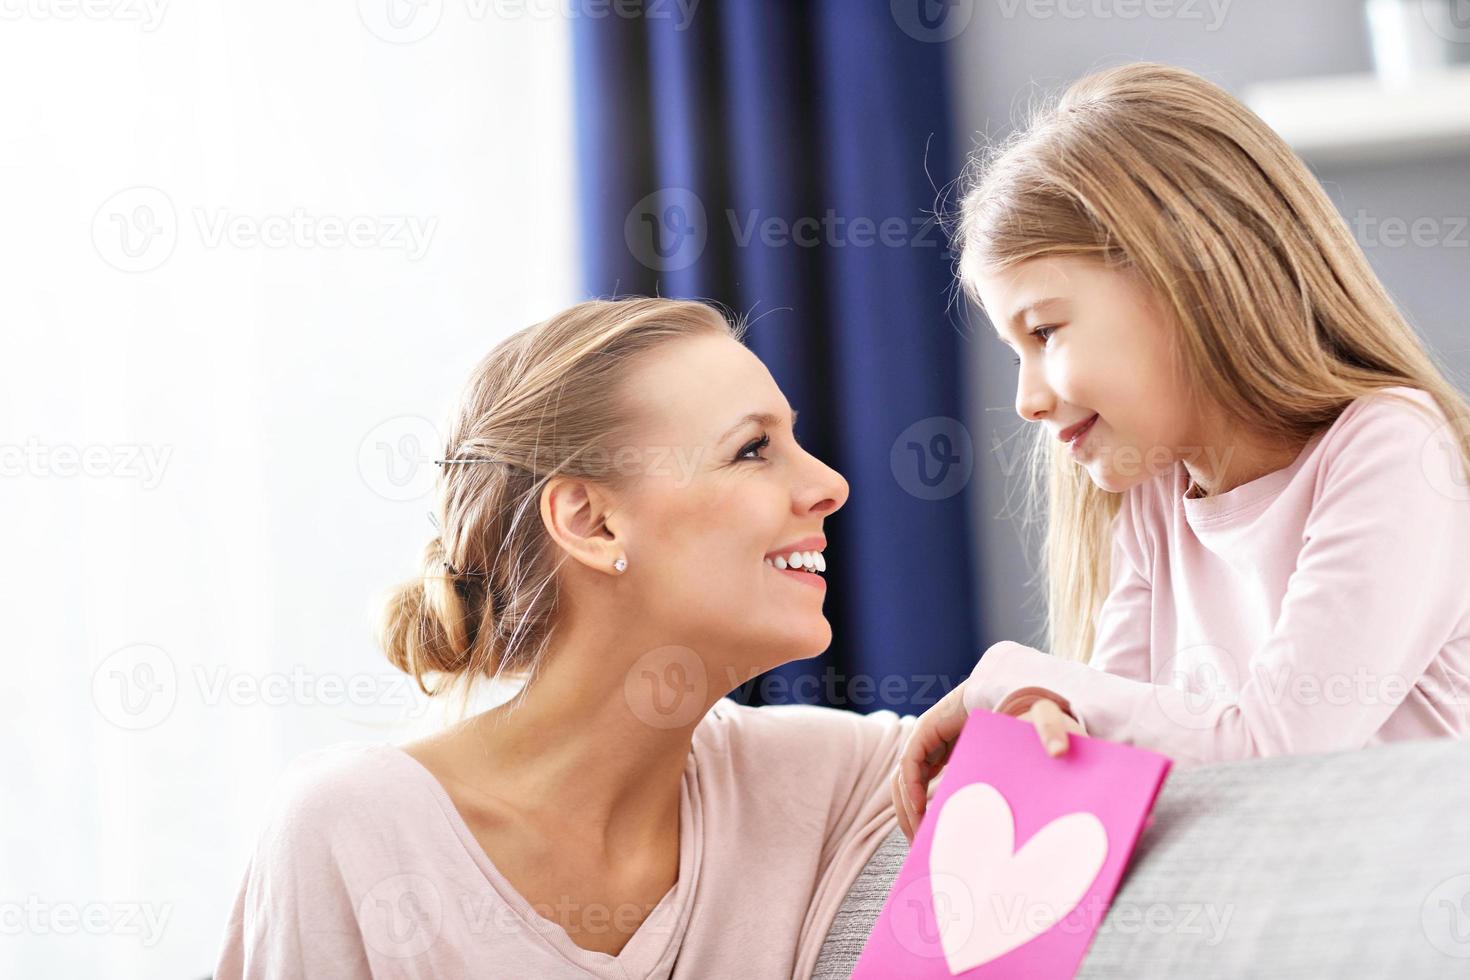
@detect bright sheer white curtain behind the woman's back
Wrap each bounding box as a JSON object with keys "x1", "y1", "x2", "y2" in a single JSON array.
[{"x1": 0, "y1": 0, "x2": 576, "y2": 979}]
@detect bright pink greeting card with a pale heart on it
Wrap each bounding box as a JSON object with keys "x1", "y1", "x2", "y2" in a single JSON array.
[{"x1": 853, "y1": 711, "x2": 1170, "y2": 980}]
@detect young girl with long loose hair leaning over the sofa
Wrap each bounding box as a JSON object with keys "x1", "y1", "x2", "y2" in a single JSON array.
[{"x1": 894, "y1": 63, "x2": 1470, "y2": 836}]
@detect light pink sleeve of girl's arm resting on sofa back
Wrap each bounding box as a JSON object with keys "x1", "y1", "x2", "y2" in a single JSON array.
[{"x1": 966, "y1": 393, "x2": 1470, "y2": 764}]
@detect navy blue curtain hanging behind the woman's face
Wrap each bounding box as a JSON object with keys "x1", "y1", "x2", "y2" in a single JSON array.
[{"x1": 573, "y1": 0, "x2": 979, "y2": 713}]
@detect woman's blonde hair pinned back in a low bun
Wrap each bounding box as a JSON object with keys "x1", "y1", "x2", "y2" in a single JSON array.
[{"x1": 378, "y1": 298, "x2": 744, "y2": 708}]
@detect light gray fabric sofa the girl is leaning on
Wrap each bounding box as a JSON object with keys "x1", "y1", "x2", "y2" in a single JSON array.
[{"x1": 814, "y1": 739, "x2": 1470, "y2": 980}]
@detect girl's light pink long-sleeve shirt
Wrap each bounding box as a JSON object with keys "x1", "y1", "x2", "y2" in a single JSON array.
[{"x1": 964, "y1": 386, "x2": 1470, "y2": 765}]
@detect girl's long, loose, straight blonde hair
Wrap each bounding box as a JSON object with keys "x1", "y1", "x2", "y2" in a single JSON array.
[{"x1": 956, "y1": 62, "x2": 1470, "y2": 663}]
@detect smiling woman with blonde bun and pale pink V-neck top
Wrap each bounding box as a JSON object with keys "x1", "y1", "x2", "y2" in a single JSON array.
[{"x1": 216, "y1": 298, "x2": 934, "y2": 980}]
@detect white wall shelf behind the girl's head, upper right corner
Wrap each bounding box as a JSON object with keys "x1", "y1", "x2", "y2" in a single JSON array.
[{"x1": 1245, "y1": 66, "x2": 1470, "y2": 163}]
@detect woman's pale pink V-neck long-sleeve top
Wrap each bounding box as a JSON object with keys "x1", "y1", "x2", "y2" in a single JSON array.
[{"x1": 215, "y1": 699, "x2": 914, "y2": 980}]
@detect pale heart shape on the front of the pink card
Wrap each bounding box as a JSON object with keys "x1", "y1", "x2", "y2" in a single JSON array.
[{"x1": 929, "y1": 783, "x2": 1107, "y2": 974}]
